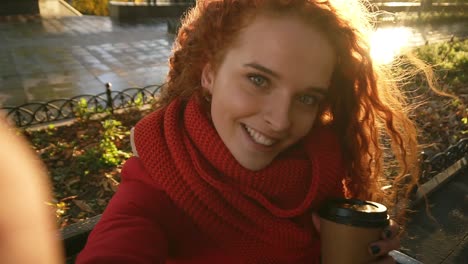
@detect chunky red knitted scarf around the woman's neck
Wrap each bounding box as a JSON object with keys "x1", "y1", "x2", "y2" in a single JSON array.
[{"x1": 135, "y1": 99, "x2": 343, "y2": 263}]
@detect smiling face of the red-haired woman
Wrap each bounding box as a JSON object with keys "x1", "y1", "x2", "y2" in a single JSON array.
[{"x1": 202, "y1": 12, "x2": 335, "y2": 171}]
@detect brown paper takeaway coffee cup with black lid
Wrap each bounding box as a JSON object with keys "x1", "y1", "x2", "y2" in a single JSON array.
[{"x1": 319, "y1": 199, "x2": 389, "y2": 264}]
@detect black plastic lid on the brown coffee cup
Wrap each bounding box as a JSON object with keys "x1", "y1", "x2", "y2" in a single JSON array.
[{"x1": 319, "y1": 199, "x2": 389, "y2": 227}]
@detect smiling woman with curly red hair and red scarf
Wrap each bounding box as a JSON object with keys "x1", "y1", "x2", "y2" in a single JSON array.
[{"x1": 78, "y1": 0, "x2": 417, "y2": 263}]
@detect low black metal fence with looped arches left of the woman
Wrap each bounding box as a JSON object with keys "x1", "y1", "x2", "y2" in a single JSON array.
[{"x1": 0, "y1": 83, "x2": 162, "y2": 128}]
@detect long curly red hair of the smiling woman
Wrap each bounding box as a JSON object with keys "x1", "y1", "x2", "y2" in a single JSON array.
[{"x1": 159, "y1": 0, "x2": 419, "y2": 219}]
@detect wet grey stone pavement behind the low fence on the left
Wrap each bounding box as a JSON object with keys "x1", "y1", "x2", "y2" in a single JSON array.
[{"x1": 0, "y1": 16, "x2": 173, "y2": 106}]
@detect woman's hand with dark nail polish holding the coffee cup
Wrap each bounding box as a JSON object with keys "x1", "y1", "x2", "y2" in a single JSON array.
[{"x1": 312, "y1": 214, "x2": 400, "y2": 264}]
